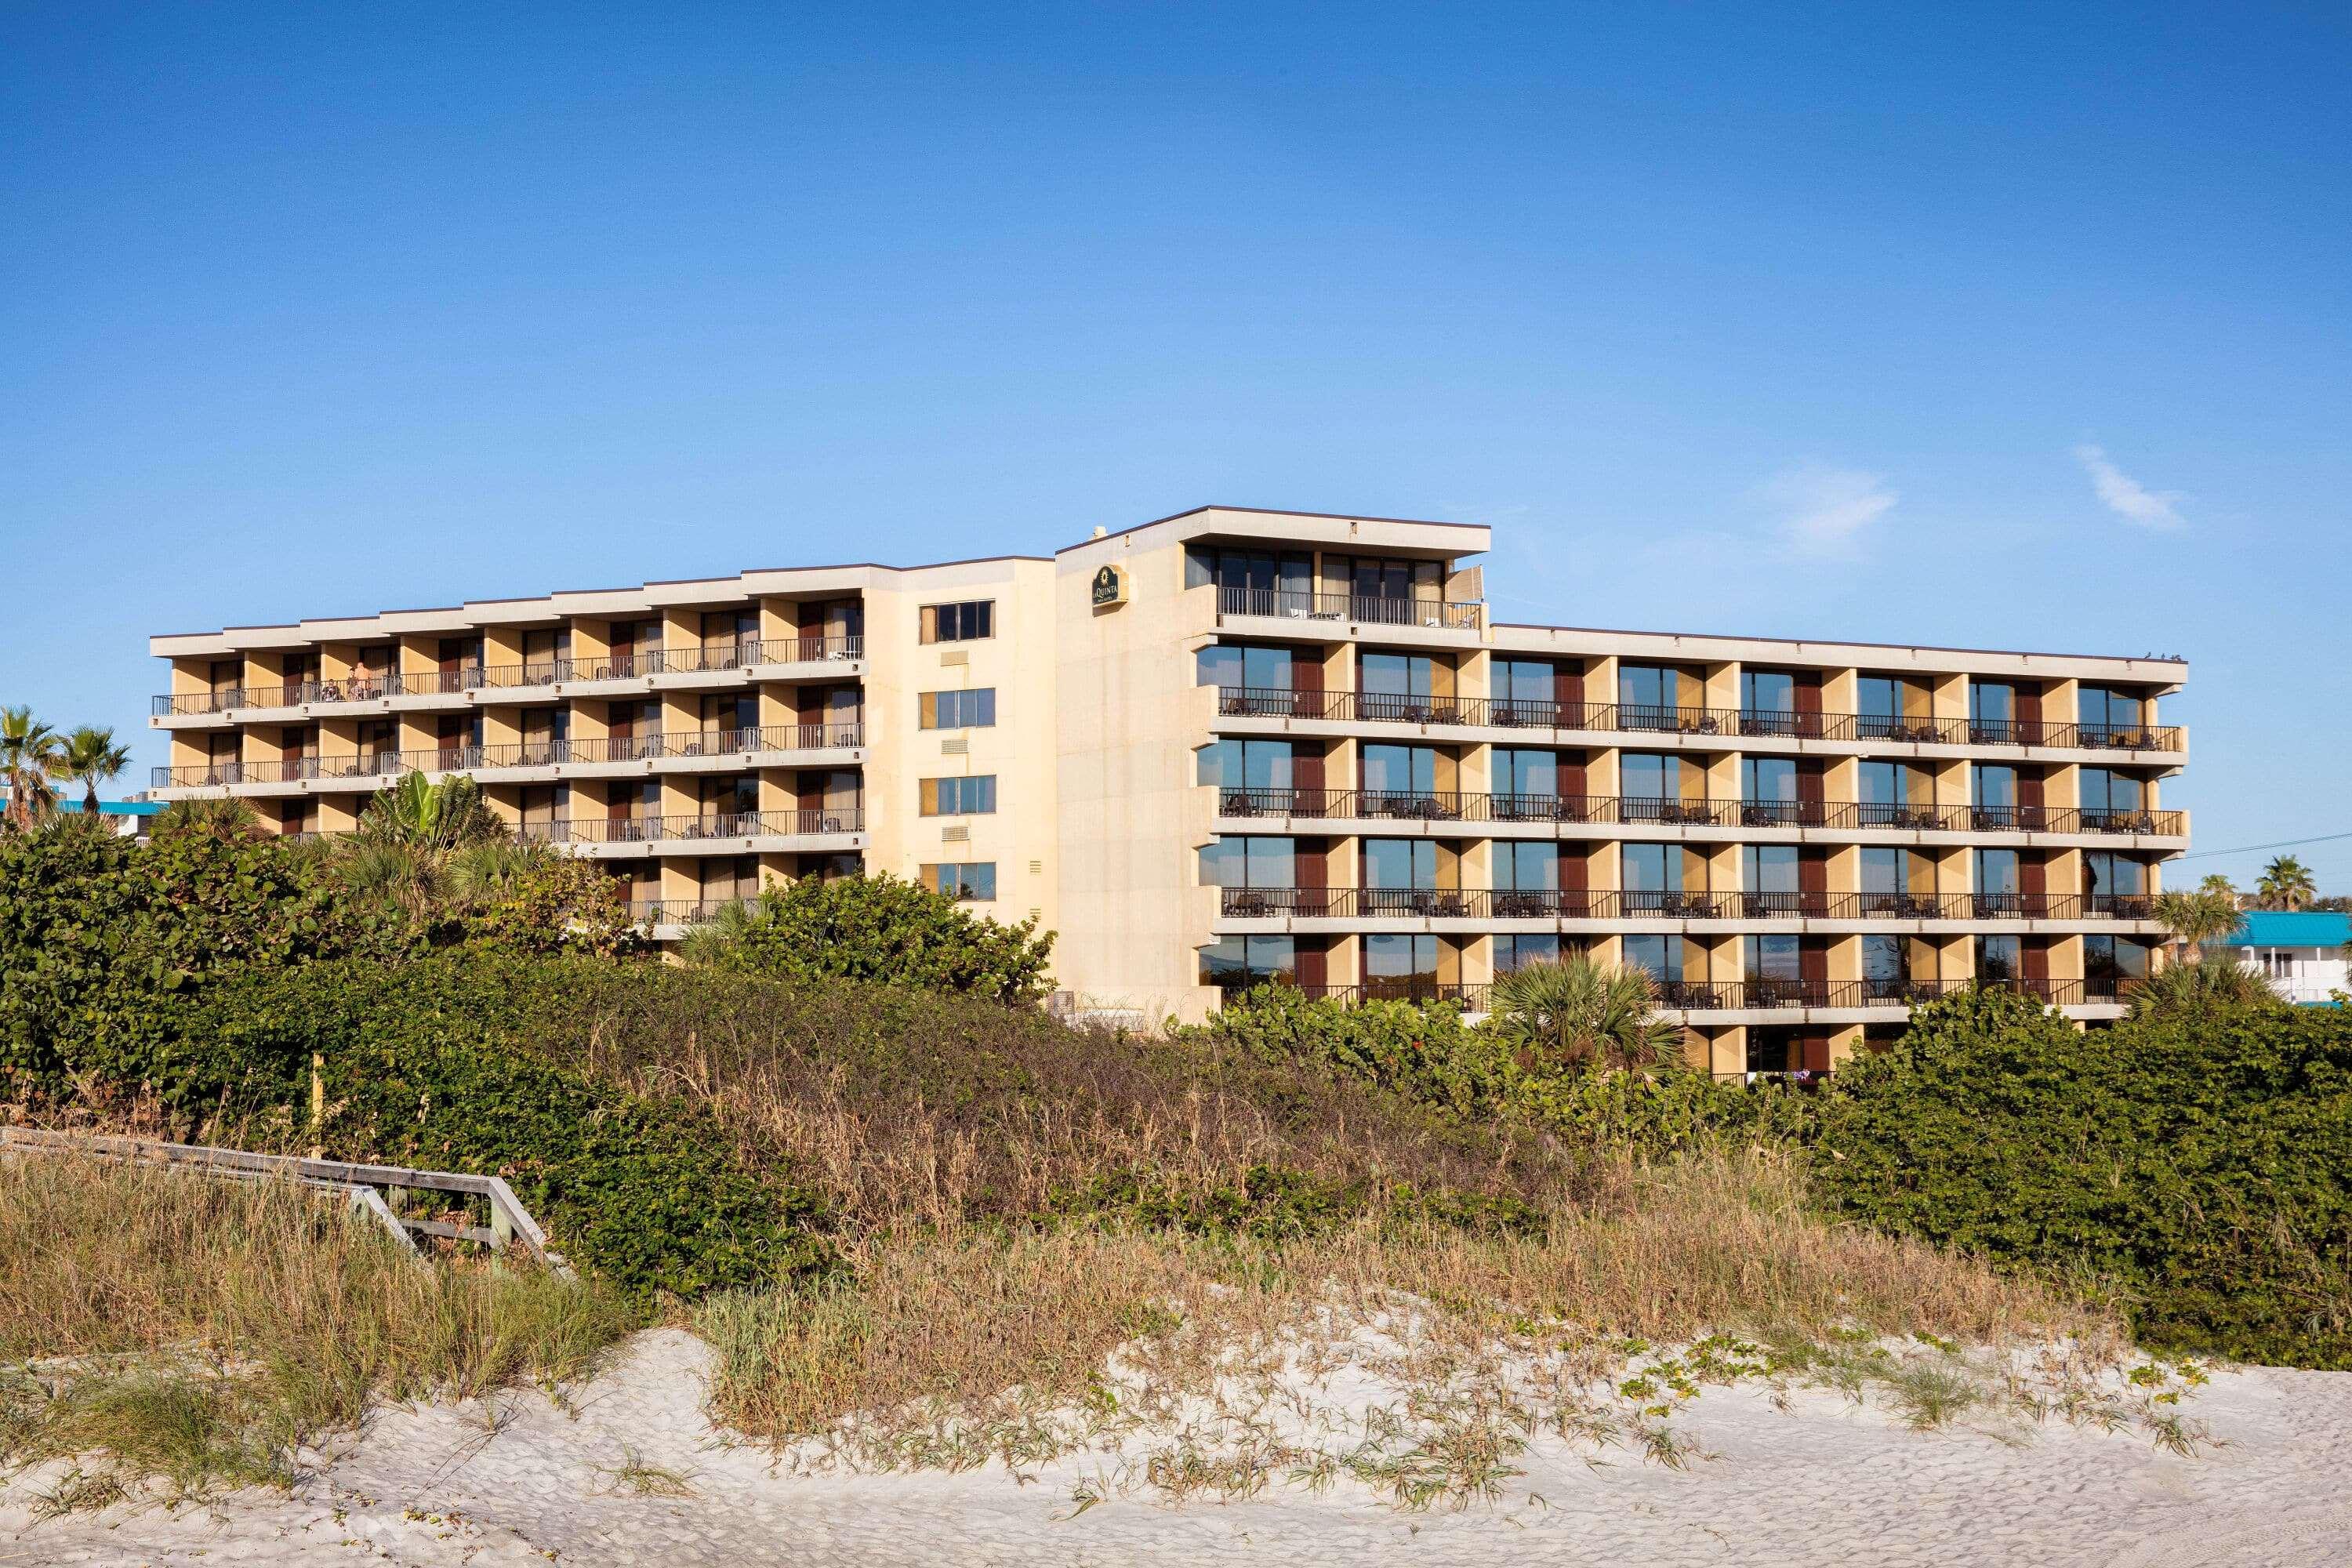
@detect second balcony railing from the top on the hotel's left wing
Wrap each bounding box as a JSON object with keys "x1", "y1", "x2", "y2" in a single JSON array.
[{"x1": 151, "y1": 724, "x2": 866, "y2": 789}]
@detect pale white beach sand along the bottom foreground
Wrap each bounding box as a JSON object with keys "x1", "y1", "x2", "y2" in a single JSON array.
[{"x1": 0, "y1": 1330, "x2": 2352, "y2": 1568}]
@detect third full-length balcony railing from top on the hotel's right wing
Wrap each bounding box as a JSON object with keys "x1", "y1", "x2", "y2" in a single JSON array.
[{"x1": 1218, "y1": 886, "x2": 2154, "y2": 928}]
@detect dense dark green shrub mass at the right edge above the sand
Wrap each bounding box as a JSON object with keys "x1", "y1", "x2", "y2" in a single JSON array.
[{"x1": 1813, "y1": 992, "x2": 2352, "y2": 1368}]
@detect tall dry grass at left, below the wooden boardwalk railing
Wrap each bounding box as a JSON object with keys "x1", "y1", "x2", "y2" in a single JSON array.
[{"x1": 0, "y1": 1156, "x2": 637, "y2": 1495}]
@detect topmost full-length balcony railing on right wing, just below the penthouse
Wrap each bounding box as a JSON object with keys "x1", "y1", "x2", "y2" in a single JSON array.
[{"x1": 1218, "y1": 687, "x2": 2180, "y2": 753}]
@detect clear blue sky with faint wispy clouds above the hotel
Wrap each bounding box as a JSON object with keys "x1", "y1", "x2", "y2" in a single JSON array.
[{"x1": 0, "y1": 5, "x2": 2352, "y2": 893}]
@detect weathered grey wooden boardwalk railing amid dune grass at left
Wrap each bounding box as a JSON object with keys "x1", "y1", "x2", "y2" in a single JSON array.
[{"x1": 0, "y1": 1126, "x2": 572, "y2": 1279}]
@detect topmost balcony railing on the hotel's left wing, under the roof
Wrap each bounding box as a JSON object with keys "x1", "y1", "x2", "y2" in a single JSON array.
[{"x1": 153, "y1": 637, "x2": 866, "y2": 720}]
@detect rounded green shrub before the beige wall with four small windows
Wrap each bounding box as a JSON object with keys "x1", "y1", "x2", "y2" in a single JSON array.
[{"x1": 684, "y1": 874, "x2": 1054, "y2": 1001}]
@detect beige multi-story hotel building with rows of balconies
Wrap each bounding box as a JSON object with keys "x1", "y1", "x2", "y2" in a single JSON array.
[{"x1": 151, "y1": 508, "x2": 2187, "y2": 1074}]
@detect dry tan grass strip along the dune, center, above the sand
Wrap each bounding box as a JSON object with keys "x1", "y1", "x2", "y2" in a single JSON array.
[{"x1": 699, "y1": 1154, "x2": 2112, "y2": 1467}]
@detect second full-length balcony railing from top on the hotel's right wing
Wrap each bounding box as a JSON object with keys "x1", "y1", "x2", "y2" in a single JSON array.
[{"x1": 1216, "y1": 787, "x2": 2187, "y2": 839}]
